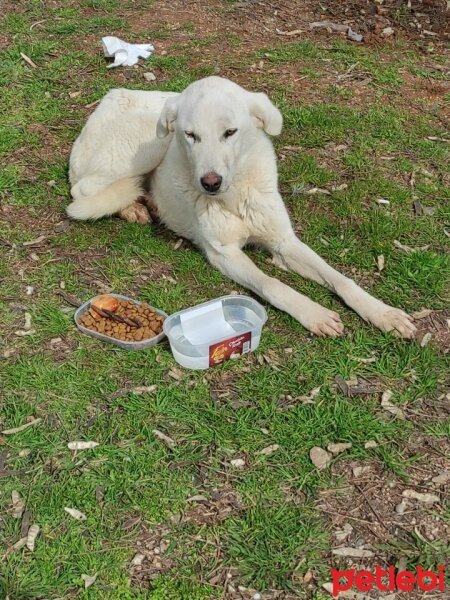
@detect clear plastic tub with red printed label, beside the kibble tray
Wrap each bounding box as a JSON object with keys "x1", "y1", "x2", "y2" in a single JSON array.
[{"x1": 163, "y1": 296, "x2": 267, "y2": 369}]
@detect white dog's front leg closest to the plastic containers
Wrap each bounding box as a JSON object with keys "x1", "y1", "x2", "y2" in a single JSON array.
[{"x1": 206, "y1": 245, "x2": 344, "y2": 337}]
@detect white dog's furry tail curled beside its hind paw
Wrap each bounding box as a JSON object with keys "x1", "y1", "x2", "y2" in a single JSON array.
[{"x1": 66, "y1": 177, "x2": 144, "y2": 221}]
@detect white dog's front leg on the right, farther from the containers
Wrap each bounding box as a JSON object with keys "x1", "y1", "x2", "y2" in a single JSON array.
[{"x1": 272, "y1": 233, "x2": 416, "y2": 338}]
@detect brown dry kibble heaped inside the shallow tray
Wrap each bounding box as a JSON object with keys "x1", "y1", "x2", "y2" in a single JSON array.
[{"x1": 80, "y1": 295, "x2": 164, "y2": 342}]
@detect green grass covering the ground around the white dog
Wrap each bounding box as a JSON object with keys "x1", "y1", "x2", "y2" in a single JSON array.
[{"x1": 0, "y1": 0, "x2": 450, "y2": 600}]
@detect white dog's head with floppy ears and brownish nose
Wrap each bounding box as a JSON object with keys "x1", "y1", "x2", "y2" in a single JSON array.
[{"x1": 156, "y1": 77, "x2": 283, "y2": 195}]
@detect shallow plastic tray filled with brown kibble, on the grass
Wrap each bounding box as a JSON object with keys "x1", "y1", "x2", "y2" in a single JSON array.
[{"x1": 75, "y1": 294, "x2": 167, "y2": 350}]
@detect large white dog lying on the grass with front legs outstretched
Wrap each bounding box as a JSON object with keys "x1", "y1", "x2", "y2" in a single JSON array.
[{"x1": 67, "y1": 77, "x2": 415, "y2": 338}]
